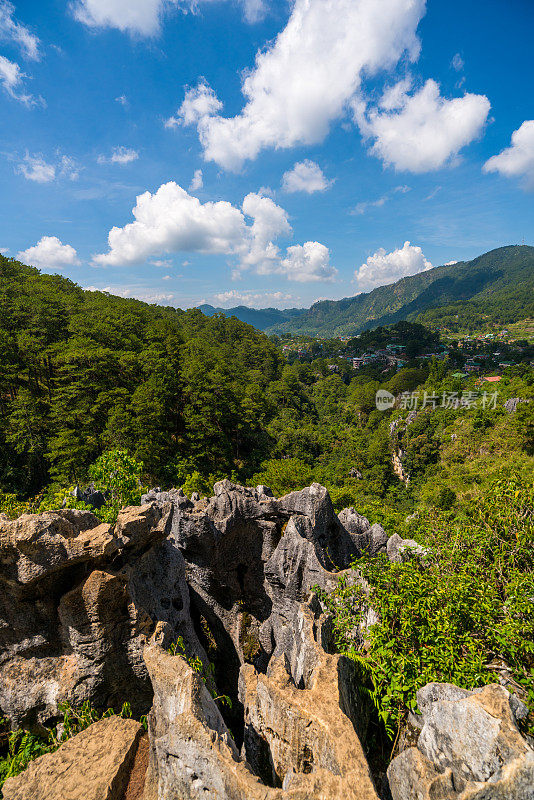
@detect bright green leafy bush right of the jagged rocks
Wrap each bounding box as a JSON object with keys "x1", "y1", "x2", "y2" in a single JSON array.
[{"x1": 322, "y1": 476, "x2": 534, "y2": 738}]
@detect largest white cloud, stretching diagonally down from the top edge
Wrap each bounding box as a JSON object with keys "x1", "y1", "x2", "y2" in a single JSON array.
[{"x1": 181, "y1": 0, "x2": 425, "y2": 169}]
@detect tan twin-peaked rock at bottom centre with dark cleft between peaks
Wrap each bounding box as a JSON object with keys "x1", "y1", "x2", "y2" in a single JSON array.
[{"x1": 140, "y1": 607, "x2": 378, "y2": 800}]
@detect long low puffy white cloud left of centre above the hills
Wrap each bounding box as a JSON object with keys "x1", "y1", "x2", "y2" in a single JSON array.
[{"x1": 93, "y1": 181, "x2": 336, "y2": 281}]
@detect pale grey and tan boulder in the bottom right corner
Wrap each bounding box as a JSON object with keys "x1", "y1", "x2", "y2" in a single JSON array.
[{"x1": 388, "y1": 683, "x2": 534, "y2": 800}]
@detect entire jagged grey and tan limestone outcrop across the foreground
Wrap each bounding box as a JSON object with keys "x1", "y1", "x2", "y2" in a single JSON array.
[{"x1": 4, "y1": 481, "x2": 533, "y2": 800}]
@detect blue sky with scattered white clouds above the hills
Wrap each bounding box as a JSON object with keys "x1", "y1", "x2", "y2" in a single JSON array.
[{"x1": 0, "y1": 0, "x2": 534, "y2": 308}]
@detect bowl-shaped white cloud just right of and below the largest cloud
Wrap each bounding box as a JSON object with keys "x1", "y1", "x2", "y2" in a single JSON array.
[{"x1": 355, "y1": 80, "x2": 490, "y2": 172}]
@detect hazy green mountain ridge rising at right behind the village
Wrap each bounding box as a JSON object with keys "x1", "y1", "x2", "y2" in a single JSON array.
[{"x1": 267, "y1": 245, "x2": 534, "y2": 336}]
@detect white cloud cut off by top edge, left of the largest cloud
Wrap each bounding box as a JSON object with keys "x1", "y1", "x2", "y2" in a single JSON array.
[{"x1": 71, "y1": 0, "x2": 265, "y2": 36}]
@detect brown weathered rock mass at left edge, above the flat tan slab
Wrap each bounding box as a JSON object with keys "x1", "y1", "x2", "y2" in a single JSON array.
[{"x1": 0, "y1": 504, "x2": 184, "y2": 728}]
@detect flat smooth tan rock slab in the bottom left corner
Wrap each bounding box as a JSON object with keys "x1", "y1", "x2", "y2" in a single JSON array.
[{"x1": 2, "y1": 717, "x2": 143, "y2": 800}]
